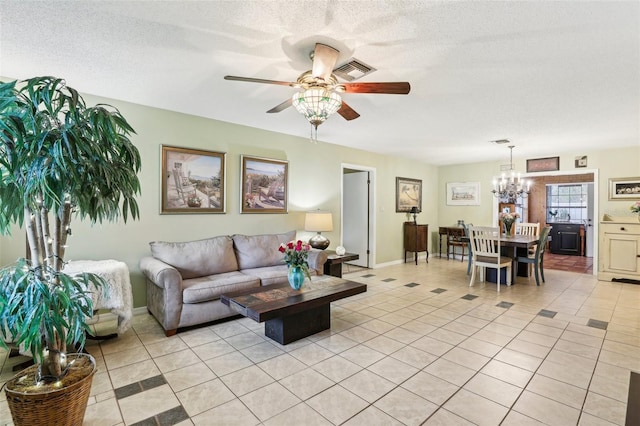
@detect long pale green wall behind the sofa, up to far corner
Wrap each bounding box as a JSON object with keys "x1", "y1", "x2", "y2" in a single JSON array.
[{"x1": 0, "y1": 95, "x2": 437, "y2": 306}]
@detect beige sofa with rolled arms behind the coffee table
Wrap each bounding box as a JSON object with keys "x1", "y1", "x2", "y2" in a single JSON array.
[{"x1": 140, "y1": 231, "x2": 327, "y2": 336}]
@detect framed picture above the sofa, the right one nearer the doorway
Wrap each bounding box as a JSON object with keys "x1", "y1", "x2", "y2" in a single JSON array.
[{"x1": 240, "y1": 155, "x2": 289, "y2": 213}]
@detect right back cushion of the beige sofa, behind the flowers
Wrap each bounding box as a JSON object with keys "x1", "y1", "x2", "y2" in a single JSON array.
[{"x1": 233, "y1": 231, "x2": 296, "y2": 269}]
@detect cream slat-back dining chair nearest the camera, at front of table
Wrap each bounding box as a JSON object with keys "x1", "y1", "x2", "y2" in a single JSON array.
[{"x1": 469, "y1": 226, "x2": 511, "y2": 292}]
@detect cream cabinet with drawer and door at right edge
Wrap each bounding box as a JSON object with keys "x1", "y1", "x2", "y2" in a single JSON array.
[{"x1": 598, "y1": 215, "x2": 640, "y2": 283}]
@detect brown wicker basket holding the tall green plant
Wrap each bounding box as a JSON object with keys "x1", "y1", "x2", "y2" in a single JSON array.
[{"x1": 5, "y1": 354, "x2": 96, "y2": 426}]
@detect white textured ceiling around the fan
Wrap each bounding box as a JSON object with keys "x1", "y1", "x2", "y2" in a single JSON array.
[{"x1": 0, "y1": 1, "x2": 640, "y2": 165}]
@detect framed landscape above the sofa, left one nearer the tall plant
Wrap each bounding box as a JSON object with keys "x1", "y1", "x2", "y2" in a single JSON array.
[{"x1": 160, "y1": 146, "x2": 226, "y2": 214}]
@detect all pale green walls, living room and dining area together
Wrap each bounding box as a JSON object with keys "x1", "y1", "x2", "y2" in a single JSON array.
[{"x1": 0, "y1": 87, "x2": 640, "y2": 307}]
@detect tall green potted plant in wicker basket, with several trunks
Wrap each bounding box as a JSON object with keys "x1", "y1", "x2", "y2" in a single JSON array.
[{"x1": 0, "y1": 77, "x2": 140, "y2": 425}]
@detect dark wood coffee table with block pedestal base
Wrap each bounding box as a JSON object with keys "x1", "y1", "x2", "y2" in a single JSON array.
[{"x1": 220, "y1": 277, "x2": 367, "y2": 345}]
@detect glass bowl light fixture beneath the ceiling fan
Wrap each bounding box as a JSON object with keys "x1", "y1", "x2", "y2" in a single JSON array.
[{"x1": 291, "y1": 87, "x2": 342, "y2": 141}]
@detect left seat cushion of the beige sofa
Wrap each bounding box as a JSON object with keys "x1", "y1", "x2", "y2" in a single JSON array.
[{"x1": 182, "y1": 271, "x2": 260, "y2": 304}]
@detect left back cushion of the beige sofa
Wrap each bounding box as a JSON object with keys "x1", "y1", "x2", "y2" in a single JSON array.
[{"x1": 149, "y1": 235, "x2": 238, "y2": 279}]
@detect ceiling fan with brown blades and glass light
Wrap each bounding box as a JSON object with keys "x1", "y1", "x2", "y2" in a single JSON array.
[{"x1": 224, "y1": 43, "x2": 411, "y2": 131}]
